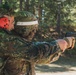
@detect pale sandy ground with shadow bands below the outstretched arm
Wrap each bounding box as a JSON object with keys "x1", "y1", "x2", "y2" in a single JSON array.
[{"x1": 36, "y1": 57, "x2": 76, "y2": 75}]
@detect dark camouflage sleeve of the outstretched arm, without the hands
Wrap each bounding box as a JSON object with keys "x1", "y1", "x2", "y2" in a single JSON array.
[{"x1": 25, "y1": 41, "x2": 61, "y2": 64}]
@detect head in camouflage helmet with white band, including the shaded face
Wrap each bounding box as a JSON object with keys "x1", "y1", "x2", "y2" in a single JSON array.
[{"x1": 15, "y1": 11, "x2": 38, "y2": 40}]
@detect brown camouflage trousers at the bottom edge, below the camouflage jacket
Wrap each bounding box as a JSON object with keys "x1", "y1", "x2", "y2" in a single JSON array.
[{"x1": 0, "y1": 58, "x2": 35, "y2": 75}]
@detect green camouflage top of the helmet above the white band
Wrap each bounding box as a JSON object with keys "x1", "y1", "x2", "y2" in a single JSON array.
[{"x1": 15, "y1": 11, "x2": 37, "y2": 22}]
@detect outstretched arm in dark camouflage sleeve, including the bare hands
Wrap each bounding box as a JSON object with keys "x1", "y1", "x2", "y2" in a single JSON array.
[{"x1": 26, "y1": 37, "x2": 75, "y2": 64}]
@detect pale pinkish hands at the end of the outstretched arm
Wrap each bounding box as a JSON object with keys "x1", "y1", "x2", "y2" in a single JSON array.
[{"x1": 56, "y1": 37, "x2": 75, "y2": 52}]
